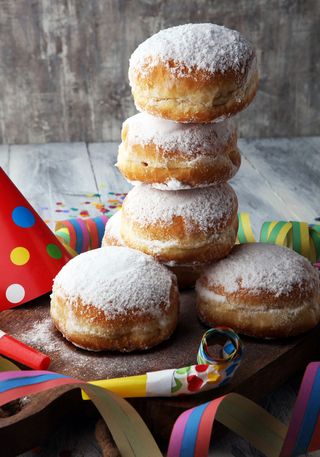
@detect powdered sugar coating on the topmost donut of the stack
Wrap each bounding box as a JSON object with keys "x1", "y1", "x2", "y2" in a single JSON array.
[{"x1": 129, "y1": 23, "x2": 254, "y2": 79}]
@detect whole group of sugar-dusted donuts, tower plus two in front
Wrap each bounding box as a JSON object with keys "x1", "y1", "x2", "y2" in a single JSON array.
[{"x1": 51, "y1": 24, "x2": 320, "y2": 351}]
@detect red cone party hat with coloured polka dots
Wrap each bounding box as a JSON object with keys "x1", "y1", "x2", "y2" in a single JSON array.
[{"x1": 0, "y1": 168, "x2": 71, "y2": 311}]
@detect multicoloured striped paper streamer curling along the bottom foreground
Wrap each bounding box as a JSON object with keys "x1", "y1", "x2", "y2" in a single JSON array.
[{"x1": 0, "y1": 360, "x2": 320, "y2": 457}]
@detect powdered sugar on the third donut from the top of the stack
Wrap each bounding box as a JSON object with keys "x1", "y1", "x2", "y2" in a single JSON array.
[{"x1": 123, "y1": 183, "x2": 237, "y2": 234}]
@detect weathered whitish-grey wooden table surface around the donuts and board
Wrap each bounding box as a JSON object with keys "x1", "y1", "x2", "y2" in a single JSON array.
[{"x1": 0, "y1": 137, "x2": 320, "y2": 457}]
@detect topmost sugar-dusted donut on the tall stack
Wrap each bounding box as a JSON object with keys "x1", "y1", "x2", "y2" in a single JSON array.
[{"x1": 129, "y1": 24, "x2": 259, "y2": 123}]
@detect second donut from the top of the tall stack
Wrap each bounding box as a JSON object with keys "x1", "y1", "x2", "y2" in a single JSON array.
[{"x1": 117, "y1": 113, "x2": 241, "y2": 190}]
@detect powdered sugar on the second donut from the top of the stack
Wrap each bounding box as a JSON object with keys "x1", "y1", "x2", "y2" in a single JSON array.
[{"x1": 123, "y1": 113, "x2": 236, "y2": 160}]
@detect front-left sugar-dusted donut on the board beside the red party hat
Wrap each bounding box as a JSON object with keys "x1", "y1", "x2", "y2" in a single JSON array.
[{"x1": 50, "y1": 246, "x2": 179, "y2": 352}]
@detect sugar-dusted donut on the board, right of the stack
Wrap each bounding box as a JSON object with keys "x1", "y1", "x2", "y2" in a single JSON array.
[{"x1": 196, "y1": 243, "x2": 320, "y2": 338}]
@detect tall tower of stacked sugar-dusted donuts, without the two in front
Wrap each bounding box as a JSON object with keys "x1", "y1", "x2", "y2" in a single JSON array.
[{"x1": 103, "y1": 24, "x2": 258, "y2": 288}]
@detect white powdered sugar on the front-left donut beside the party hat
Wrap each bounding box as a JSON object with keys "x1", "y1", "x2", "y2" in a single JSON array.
[{"x1": 52, "y1": 246, "x2": 173, "y2": 318}]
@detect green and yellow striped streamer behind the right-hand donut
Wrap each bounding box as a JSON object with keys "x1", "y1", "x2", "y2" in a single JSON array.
[{"x1": 237, "y1": 213, "x2": 320, "y2": 262}]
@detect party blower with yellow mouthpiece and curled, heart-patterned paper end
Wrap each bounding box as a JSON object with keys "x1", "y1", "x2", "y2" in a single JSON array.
[{"x1": 83, "y1": 327, "x2": 242, "y2": 400}]
